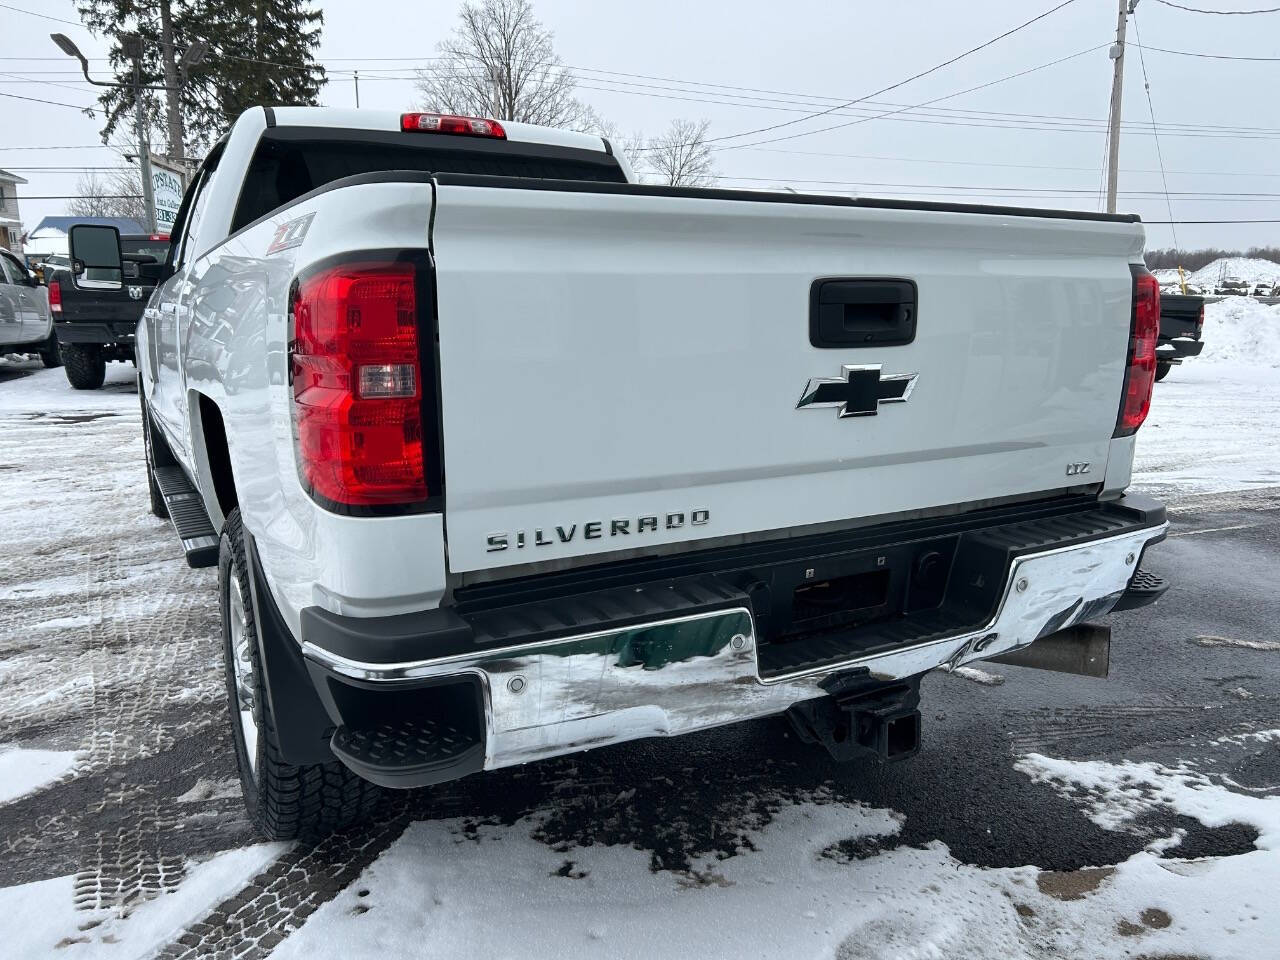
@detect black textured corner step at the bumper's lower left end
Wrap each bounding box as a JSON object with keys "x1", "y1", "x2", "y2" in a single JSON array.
[{"x1": 330, "y1": 718, "x2": 484, "y2": 787}]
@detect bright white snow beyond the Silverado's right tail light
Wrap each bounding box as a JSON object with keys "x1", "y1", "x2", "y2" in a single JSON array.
[{"x1": 1133, "y1": 297, "x2": 1280, "y2": 498}]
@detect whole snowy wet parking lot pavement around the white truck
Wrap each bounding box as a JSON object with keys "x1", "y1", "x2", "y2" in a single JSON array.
[{"x1": 0, "y1": 305, "x2": 1280, "y2": 960}]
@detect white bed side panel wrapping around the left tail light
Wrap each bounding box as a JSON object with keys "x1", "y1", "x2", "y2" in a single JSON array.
[{"x1": 180, "y1": 182, "x2": 444, "y2": 631}]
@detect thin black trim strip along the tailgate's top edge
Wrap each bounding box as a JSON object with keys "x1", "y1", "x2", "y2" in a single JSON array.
[{"x1": 434, "y1": 173, "x2": 1142, "y2": 223}]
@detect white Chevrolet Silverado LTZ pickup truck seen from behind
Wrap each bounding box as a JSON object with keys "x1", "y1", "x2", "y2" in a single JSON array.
[{"x1": 72, "y1": 108, "x2": 1166, "y2": 837}]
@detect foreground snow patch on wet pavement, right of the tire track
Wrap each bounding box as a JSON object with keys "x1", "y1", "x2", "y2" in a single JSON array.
[{"x1": 264, "y1": 731, "x2": 1280, "y2": 960}]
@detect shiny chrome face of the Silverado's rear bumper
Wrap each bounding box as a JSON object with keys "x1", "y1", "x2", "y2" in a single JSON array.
[{"x1": 302, "y1": 522, "x2": 1167, "y2": 769}]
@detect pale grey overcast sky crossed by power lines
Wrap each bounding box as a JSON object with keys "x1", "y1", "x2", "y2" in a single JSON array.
[{"x1": 0, "y1": 0, "x2": 1280, "y2": 248}]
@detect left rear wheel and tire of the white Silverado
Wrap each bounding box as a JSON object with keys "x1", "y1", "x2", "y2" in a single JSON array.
[{"x1": 218, "y1": 508, "x2": 381, "y2": 840}]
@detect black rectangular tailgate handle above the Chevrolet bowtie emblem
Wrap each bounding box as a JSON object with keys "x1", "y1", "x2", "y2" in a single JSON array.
[{"x1": 809, "y1": 278, "x2": 916, "y2": 348}]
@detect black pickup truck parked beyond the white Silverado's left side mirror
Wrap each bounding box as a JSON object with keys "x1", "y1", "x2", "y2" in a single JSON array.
[{"x1": 46, "y1": 234, "x2": 169, "y2": 390}]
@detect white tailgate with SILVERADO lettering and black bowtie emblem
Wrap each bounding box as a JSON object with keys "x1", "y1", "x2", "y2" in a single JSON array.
[{"x1": 431, "y1": 178, "x2": 1143, "y2": 572}]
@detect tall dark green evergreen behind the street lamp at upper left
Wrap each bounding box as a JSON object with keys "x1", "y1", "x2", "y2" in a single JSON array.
[{"x1": 77, "y1": 0, "x2": 325, "y2": 156}]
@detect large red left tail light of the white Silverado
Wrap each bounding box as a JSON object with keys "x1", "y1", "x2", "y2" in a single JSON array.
[{"x1": 292, "y1": 261, "x2": 428, "y2": 507}]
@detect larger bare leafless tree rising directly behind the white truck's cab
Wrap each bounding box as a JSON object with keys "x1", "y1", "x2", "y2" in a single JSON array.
[{"x1": 417, "y1": 0, "x2": 599, "y2": 129}]
